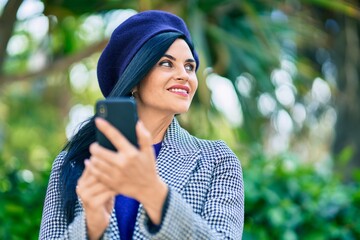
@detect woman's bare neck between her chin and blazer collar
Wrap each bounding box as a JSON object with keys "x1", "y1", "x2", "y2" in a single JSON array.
[{"x1": 139, "y1": 111, "x2": 174, "y2": 144}]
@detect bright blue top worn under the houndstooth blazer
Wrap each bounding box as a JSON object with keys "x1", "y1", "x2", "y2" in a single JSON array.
[{"x1": 115, "y1": 142, "x2": 162, "y2": 239}]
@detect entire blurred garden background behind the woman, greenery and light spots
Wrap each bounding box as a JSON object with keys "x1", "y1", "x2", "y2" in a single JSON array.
[{"x1": 0, "y1": 0, "x2": 360, "y2": 240}]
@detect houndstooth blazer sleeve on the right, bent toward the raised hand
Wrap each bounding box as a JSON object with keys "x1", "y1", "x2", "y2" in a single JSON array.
[{"x1": 140, "y1": 141, "x2": 244, "y2": 239}]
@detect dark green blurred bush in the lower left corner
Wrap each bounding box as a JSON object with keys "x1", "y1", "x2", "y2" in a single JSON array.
[{"x1": 0, "y1": 168, "x2": 50, "y2": 239}]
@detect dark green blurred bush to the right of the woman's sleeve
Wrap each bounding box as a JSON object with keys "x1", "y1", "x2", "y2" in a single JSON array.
[{"x1": 243, "y1": 150, "x2": 360, "y2": 240}]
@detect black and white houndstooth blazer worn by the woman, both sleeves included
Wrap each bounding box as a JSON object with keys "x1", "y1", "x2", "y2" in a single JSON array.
[{"x1": 39, "y1": 119, "x2": 244, "y2": 240}]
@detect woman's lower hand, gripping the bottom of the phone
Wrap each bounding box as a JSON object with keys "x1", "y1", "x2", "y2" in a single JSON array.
[{"x1": 76, "y1": 160, "x2": 115, "y2": 239}]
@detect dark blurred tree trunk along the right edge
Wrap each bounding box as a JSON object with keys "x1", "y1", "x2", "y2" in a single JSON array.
[{"x1": 333, "y1": 11, "x2": 360, "y2": 181}]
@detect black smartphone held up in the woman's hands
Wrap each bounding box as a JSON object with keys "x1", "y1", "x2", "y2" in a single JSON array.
[{"x1": 95, "y1": 98, "x2": 138, "y2": 151}]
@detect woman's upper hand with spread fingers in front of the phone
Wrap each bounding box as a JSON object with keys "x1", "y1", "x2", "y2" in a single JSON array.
[{"x1": 90, "y1": 118, "x2": 168, "y2": 224}]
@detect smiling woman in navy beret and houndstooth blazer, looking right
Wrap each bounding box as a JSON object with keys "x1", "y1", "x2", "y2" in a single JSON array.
[{"x1": 40, "y1": 11, "x2": 244, "y2": 239}]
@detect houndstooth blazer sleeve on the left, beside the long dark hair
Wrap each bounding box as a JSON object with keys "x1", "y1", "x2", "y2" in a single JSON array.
[{"x1": 39, "y1": 152, "x2": 86, "y2": 239}]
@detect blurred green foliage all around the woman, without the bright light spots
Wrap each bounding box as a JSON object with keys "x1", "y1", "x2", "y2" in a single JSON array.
[{"x1": 0, "y1": 0, "x2": 360, "y2": 240}]
